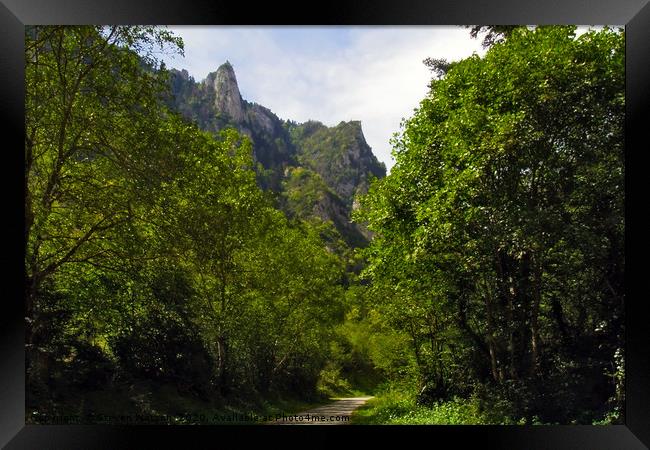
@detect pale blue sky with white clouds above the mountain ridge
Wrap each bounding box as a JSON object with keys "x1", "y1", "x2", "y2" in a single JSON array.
[{"x1": 162, "y1": 26, "x2": 485, "y2": 170}]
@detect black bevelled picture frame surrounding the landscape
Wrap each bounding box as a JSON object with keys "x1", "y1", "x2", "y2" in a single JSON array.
[{"x1": 0, "y1": 0, "x2": 650, "y2": 450}]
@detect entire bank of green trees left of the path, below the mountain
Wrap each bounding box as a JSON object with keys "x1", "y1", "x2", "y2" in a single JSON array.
[{"x1": 25, "y1": 26, "x2": 347, "y2": 417}]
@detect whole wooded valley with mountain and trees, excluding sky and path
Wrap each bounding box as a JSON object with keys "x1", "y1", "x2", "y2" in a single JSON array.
[{"x1": 24, "y1": 26, "x2": 625, "y2": 424}]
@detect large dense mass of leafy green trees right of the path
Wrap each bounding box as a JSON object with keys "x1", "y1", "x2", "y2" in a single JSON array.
[{"x1": 357, "y1": 27, "x2": 624, "y2": 423}]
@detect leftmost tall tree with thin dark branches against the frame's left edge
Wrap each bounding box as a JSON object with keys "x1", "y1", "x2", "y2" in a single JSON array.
[{"x1": 24, "y1": 26, "x2": 182, "y2": 386}]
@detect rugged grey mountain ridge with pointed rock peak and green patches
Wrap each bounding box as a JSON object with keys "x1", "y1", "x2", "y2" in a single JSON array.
[{"x1": 170, "y1": 62, "x2": 386, "y2": 246}]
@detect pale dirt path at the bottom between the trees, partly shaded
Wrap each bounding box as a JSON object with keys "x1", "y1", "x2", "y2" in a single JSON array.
[{"x1": 267, "y1": 397, "x2": 373, "y2": 425}]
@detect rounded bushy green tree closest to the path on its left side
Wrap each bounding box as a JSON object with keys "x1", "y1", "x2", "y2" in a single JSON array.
[{"x1": 239, "y1": 209, "x2": 344, "y2": 395}]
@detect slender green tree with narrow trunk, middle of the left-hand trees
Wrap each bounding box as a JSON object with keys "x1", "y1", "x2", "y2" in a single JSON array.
[{"x1": 160, "y1": 126, "x2": 264, "y2": 392}]
